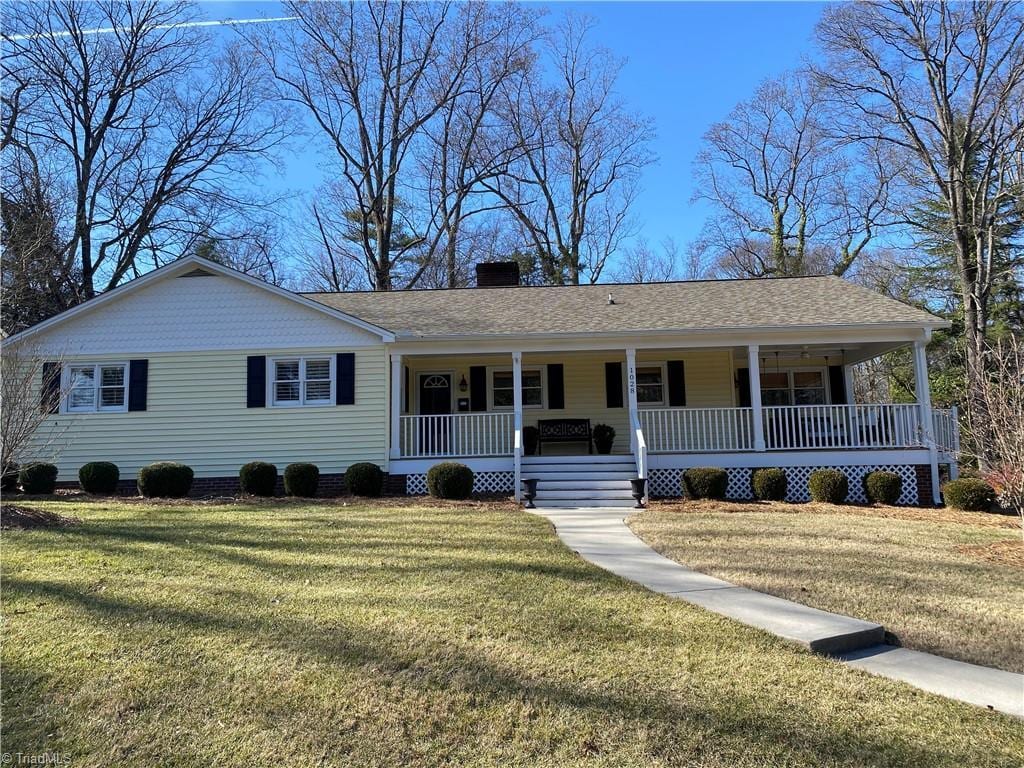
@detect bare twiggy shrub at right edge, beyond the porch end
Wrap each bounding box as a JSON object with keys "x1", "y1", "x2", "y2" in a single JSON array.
[{"x1": 967, "y1": 337, "x2": 1024, "y2": 519}]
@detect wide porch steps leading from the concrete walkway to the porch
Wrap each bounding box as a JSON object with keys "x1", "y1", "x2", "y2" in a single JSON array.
[{"x1": 522, "y1": 455, "x2": 636, "y2": 509}]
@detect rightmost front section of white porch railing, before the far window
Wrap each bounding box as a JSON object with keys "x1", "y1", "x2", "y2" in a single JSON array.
[{"x1": 764, "y1": 403, "x2": 925, "y2": 451}]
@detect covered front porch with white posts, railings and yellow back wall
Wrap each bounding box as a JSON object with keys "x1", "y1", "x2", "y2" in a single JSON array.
[{"x1": 389, "y1": 339, "x2": 958, "y2": 501}]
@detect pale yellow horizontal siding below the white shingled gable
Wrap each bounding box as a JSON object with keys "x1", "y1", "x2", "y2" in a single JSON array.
[{"x1": 29, "y1": 346, "x2": 387, "y2": 481}]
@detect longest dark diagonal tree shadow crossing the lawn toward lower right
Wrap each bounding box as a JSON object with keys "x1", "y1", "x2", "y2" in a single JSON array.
[{"x1": 4, "y1": 578, "x2": 970, "y2": 766}]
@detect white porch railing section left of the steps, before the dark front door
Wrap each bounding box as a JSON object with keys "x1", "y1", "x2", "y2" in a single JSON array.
[{"x1": 399, "y1": 413, "x2": 513, "y2": 459}]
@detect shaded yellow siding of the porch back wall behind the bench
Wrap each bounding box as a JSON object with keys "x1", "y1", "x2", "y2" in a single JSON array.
[{"x1": 403, "y1": 349, "x2": 733, "y2": 454}]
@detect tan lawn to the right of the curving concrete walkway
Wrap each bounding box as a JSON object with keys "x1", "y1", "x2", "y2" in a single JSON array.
[{"x1": 630, "y1": 502, "x2": 1024, "y2": 672}]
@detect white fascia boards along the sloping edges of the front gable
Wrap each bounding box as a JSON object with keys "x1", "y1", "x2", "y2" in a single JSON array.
[{"x1": 4, "y1": 256, "x2": 395, "y2": 344}]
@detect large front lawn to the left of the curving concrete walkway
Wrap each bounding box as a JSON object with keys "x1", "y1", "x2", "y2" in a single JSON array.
[{"x1": 2, "y1": 503, "x2": 1024, "y2": 768}]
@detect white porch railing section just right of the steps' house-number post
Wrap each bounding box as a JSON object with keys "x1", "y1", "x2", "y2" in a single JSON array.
[{"x1": 640, "y1": 408, "x2": 754, "y2": 454}]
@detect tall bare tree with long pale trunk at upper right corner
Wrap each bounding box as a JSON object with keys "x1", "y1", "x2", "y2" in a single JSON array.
[{"x1": 815, "y1": 1, "x2": 1024, "y2": 464}]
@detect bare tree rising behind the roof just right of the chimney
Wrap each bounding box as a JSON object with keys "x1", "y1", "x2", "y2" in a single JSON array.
[{"x1": 490, "y1": 14, "x2": 653, "y2": 284}]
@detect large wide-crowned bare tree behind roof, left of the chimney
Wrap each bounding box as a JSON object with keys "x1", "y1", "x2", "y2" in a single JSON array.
[{"x1": 251, "y1": 2, "x2": 529, "y2": 291}]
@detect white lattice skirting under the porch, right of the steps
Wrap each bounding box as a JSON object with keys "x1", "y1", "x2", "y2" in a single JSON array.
[{"x1": 647, "y1": 464, "x2": 918, "y2": 505}]
